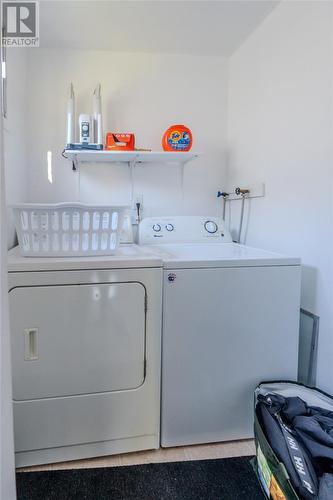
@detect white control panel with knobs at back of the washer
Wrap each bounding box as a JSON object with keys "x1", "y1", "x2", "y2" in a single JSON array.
[{"x1": 139, "y1": 215, "x2": 232, "y2": 245}]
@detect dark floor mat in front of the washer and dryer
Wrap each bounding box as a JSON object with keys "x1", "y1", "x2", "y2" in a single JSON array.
[{"x1": 17, "y1": 457, "x2": 264, "y2": 500}]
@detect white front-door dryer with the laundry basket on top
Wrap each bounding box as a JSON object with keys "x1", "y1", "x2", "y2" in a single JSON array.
[{"x1": 8, "y1": 245, "x2": 162, "y2": 466}]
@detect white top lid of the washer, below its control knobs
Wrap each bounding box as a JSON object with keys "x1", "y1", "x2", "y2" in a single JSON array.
[{"x1": 147, "y1": 243, "x2": 301, "y2": 269}]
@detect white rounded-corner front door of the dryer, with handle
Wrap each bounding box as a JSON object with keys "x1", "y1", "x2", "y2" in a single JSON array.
[{"x1": 9, "y1": 283, "x2": 145, "y2": 401}]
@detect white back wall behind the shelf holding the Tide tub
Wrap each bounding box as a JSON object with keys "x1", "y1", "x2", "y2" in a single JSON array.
[{"x1": 28, "y1": 49, "x2": 227, "y2": 219}]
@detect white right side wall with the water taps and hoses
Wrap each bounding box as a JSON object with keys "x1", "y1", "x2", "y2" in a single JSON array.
[{"x1": 228, "y1": 1, "x2": 333, "y2": 392}]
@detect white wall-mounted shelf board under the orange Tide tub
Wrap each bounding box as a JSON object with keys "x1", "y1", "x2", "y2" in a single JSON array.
[{"x1": 63, "y1": 149, "x2": 200, "y2": 170}]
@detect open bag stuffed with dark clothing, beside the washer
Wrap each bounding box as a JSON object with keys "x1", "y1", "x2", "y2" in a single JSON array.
[{"x1": 253, "y1": 382, "x2": 333, "y2": 500}]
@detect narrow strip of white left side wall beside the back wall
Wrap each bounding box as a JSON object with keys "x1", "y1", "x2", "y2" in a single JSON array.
[{"x1": 4, "y1": 48, "x2": 28, "y2": 248}]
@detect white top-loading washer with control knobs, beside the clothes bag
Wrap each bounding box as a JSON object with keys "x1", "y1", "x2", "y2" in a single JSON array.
[{"x1": 139, "y1": 217, "x2": 300, "y2": 447}]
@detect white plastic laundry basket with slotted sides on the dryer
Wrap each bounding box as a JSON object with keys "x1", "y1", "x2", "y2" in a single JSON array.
[{"x1": 12, "y1": 203, "x2": 128, "y2": 257}]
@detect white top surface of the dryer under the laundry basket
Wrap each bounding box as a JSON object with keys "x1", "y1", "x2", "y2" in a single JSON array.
[{"x1": 8, "y1": 244, "x2": 162, "y2": 272}]
